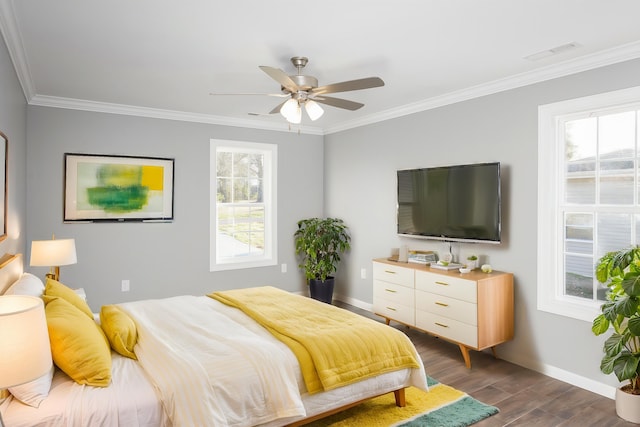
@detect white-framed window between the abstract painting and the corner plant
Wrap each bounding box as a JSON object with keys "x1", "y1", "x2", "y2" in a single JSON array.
[{"x1": 210, "y1": 139, "x2": 278, "y2": 271}]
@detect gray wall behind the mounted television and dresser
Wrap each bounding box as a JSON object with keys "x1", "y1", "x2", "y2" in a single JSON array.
[{"x1": 325, "y1": 60, "x2": 640, "y2": 396}]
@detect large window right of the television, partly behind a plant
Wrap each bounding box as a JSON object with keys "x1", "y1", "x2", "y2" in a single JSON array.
[{"x1": 538, "y1": 88, "x2": 640, "y2": 322}]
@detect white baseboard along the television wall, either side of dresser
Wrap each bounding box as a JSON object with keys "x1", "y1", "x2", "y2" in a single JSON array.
[{"x1": 334, "y1": 295, "x2": 616, "y2": 399}]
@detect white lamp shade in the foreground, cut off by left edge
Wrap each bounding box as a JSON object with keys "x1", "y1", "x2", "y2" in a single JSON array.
[{"x1": 0, "y1": 295, "x2": 52, "y2": 388}]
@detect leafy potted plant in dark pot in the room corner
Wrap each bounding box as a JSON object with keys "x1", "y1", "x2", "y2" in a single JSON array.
[{"x1": 294, "y1": 218, "x2": 351, "y2": 304}]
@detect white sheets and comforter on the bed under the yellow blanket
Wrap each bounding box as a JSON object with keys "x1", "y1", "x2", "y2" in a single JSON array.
[{"x1": 1, "y1": 296, "x2": 427, "y2": 427}]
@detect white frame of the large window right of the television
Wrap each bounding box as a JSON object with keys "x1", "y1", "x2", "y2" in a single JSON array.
[{"x1": 537, "y1": 87, "x2": 640, "y2": 322}]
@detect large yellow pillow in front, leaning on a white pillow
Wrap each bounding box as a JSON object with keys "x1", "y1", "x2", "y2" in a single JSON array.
[{"x1": 43, "y1": 295, "x2": 111, "y2": 387}]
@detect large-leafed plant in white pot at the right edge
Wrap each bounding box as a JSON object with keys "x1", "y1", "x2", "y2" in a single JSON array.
[{"x1": 591, "y1": 246, "x2": 640, "y2": 423}]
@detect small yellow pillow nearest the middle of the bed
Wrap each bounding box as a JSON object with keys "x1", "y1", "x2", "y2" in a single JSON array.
[{"x1": 100, "y1": 305, "x2": 138, "y2": 360}]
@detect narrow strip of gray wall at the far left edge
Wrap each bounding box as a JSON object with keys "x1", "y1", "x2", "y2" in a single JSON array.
[{"x1": 0, "y1": 31, "x2": 27, "y2": 256}]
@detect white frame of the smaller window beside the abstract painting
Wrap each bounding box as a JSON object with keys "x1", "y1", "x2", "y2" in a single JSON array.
[{"x1": 209, "y1": 139, "x2": 278, "y2": 271}]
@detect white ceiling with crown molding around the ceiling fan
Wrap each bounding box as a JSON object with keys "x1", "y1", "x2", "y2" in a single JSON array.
[{"x1": 0, "y1": 0, "x2": 640, "y2": 134}]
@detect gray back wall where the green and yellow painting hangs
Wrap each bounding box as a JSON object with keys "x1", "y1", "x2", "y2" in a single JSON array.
[{"x1": 27, "y1": 106, "x2": 323, "y2": 311}]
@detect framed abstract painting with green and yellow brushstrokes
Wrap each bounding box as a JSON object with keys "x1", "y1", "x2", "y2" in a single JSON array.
[{"x1": 64, "y1": 153, "x2": 175, "y2": 222}]
